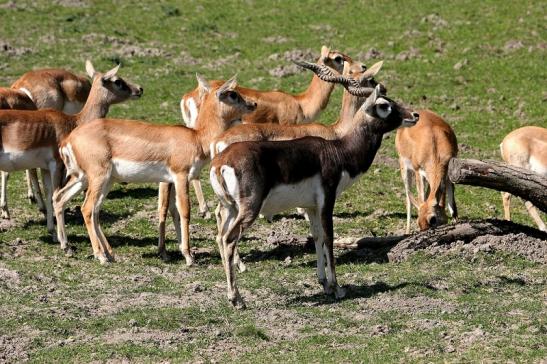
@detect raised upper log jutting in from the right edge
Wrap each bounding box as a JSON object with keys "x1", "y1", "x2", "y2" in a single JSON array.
[{"x1": 448, "y1": 158, "x2": 547, "y2": 213}]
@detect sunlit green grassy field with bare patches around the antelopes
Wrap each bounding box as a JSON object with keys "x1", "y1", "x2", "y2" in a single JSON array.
[{"x1": 0, "y1": 0, "x2": 547, "y2": 362}]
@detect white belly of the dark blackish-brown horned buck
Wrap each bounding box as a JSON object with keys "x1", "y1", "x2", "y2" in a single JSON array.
[{"x1": 260, "y1": 175, "x2": 325, "y2": 216}]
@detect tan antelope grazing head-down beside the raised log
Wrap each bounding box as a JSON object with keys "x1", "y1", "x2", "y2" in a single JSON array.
[{"x1": 395, "y1": 110, "x2": 458, "y2": 234}]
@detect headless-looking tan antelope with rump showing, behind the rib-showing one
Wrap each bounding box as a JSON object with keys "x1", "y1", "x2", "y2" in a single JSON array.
[{"x1": 0, "y1": 69, "x2": 91, "y2": 216}]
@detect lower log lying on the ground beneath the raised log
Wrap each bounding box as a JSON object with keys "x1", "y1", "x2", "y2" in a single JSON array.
[{"x1": 387, "y1": 219, "x2": 547, "y2": 262}]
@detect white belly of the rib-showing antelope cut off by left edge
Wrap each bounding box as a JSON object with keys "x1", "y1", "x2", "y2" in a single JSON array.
[{"x1": 0, "y1": 147, "x2": 54, "y2": 172}]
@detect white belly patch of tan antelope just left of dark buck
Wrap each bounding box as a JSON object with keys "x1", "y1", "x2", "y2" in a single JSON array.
[{"x1": 112, "y1": 158, "x2": 173, "y2": 183}]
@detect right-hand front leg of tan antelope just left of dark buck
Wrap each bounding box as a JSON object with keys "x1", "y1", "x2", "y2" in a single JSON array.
[{"x1": 175, "y1": 173, "x2": 194, "y2": 266}]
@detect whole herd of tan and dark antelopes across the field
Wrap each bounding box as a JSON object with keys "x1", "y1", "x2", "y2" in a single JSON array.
[{"x1": 0, "y1": 46, "x2": 547, "y2": 307}]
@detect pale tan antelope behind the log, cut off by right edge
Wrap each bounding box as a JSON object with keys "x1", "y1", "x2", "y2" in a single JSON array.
[{"x1": 500, "y1": 126, "x2": 547, "y2": 231}]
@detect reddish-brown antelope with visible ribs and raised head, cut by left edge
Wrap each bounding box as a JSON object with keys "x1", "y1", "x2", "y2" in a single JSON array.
[{"x1": 0, "y1": 61, "x2": 142, "y2": 241}]
